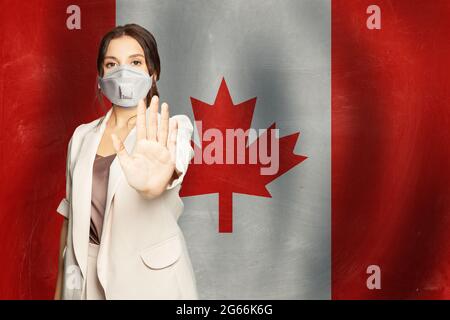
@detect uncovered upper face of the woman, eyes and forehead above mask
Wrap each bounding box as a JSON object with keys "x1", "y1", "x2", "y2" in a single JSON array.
[{"x1": 103, "y1": 36, "x2": 148, "y2": 75}]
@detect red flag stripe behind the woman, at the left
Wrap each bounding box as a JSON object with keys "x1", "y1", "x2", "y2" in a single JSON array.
[{"x1": 0, "y1": 0, "x2": 115, "y2": 299}]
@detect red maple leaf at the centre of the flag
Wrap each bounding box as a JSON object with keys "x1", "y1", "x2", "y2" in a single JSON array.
[{"x1": 180, "y1": 78, "x2": 307, "y2": 232}]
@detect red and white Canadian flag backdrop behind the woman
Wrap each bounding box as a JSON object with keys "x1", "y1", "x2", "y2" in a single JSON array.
[{"x1": 0, "y1": 0, "x2": 450, "y2": 299}]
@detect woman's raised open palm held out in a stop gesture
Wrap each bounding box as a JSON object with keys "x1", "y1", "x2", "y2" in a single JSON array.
[{"x1": 111, "y1": 96, "x2": 177, "y2": 198}]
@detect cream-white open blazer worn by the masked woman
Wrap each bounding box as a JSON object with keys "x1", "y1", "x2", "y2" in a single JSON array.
[{"x1": 57, "y1": 108, "x2": 198, "y2": 299}]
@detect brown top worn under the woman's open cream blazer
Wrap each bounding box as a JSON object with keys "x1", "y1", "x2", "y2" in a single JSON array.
[{"x1": 89, "y1": 153, "x2": 116, "y2": 244}]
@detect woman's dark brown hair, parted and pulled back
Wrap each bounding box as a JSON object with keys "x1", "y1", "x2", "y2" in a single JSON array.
[{"x1": 97, "y1": 23, "x2": 161, "y2": 126}]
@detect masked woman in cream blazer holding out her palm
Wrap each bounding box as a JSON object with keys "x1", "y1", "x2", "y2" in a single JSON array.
[{"x1": 55, "y1": 24, "x2": 198, "y2": 299}]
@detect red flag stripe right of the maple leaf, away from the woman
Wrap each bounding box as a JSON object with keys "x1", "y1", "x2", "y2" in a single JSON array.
[{"x1": 332, "y1": 0, "x2": 450, "y2": 299}]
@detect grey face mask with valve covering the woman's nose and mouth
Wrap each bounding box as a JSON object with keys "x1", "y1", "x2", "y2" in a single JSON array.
[{"x1": 97, "y1": 65, "x2": 152, "y2": 107}]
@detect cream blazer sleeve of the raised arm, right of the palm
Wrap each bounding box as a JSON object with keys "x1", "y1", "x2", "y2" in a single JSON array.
[{"x1": 166, "y1": 114, "x2": 194, "y2": 190}]
